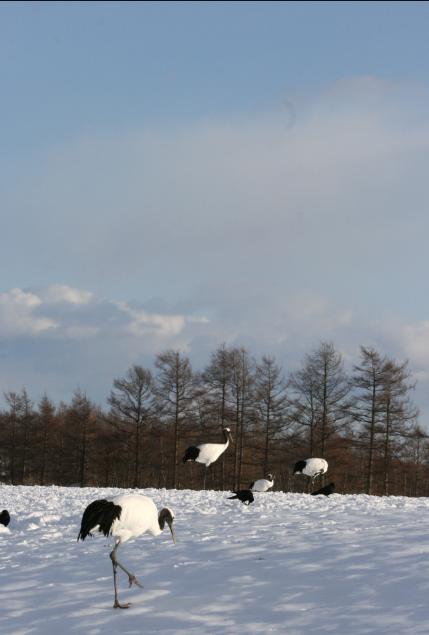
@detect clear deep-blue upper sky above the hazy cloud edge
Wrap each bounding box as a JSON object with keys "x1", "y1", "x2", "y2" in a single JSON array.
[{"x1": 0, "y1": 2, "x2": 429, "y2": 155}]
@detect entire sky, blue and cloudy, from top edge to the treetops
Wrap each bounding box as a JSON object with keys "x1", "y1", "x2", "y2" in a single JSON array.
[{"x1": 0, "y1": 2, "x2": 429, "y2": 423}]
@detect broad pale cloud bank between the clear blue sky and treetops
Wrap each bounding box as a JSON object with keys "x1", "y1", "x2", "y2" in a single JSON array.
[{"x1": 0, "y1": 77, "x2": 429, "y2": 414}]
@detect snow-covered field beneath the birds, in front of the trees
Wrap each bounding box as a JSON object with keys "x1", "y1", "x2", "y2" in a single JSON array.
[{"x1": 0, "y1": 486, "x2": 429, "y2": 635}]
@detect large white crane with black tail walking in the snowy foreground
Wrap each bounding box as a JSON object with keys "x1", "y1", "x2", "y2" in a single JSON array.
[{"x1": 77, "y1": 494, "x2": 176, "y2": 609}]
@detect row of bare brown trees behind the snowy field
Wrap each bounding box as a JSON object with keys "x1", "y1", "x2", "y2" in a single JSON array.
[{"x1": 0, "y1": 342, "x2": 429, "y2": 496}]
